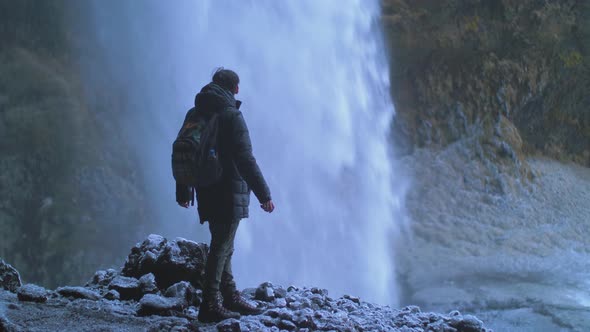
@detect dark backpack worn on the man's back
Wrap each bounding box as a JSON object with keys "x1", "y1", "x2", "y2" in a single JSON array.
[{"x1": 172, "y1": 110, "x2": 223, "y2": 189}]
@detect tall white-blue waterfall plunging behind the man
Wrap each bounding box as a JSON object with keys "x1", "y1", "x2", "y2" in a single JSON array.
[{"x1": 86, "y1": 0, "x2": 402, "y2": 304}]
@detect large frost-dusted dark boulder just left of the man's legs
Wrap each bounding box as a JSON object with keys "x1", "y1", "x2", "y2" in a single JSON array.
[{"x1": 122, "y1": 234, "x2": 209, "y2": 288}]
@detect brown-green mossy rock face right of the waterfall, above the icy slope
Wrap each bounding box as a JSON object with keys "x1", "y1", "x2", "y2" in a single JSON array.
[{"x1": 382, "y1": 0, "x2": 590, "y2": 165}]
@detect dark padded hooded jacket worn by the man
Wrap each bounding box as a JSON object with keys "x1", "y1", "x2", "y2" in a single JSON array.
[{"x1": 176, "y1": 83, "x2": 271, "y2": 223}]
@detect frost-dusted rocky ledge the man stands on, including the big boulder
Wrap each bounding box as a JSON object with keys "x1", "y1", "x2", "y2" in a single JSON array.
[{"x1": 0, "y1": 235, "x2": 486, "y2": 332}]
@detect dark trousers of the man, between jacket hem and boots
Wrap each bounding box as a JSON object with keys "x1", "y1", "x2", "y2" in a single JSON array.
[{"x1": 204, "y1": 219, "x2": 240, "y2": 297}]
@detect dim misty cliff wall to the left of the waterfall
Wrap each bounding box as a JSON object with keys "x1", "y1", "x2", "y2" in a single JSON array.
[{"x1": 0, "y1": 0, "x2": 155, "y2": 287}]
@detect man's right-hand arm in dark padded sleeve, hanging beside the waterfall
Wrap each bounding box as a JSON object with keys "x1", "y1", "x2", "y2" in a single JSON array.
[{"x1": 232, "y1": 112, "x2": 271, "y2": 205}]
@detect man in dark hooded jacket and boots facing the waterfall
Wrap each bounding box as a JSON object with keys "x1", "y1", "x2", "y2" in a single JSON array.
[{"x1": 176, "y1": 68, "x2": 274, "y2": 322}]
